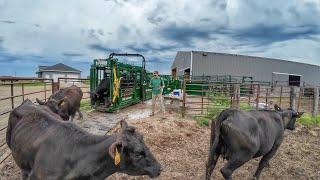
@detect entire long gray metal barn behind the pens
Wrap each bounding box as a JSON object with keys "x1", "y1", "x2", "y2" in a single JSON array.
[{"x1": 171, "y1": 51, "x2": 320, "y2": 86}]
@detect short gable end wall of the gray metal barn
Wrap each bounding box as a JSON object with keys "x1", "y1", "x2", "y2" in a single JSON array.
[{"x1": 171, "y1": 51, "x2": 191, "y2": 76}]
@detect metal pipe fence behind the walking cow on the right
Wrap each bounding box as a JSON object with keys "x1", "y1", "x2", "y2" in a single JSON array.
[{"x1": 181, "y1": 79, "x2": 320, "y2": 117}]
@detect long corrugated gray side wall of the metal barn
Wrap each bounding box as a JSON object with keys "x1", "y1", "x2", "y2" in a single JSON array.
[{"x1": 188, "y1": 51, "x2": 320, "y2": 85}]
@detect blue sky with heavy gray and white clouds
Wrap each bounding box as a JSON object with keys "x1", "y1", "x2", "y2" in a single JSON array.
[{"x1": 0, "y1": 0, "x2": 320, "y2": 76}]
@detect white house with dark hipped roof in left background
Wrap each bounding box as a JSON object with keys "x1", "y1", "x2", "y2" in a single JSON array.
[{"x1": 36, "y1": 63, "x2": 81, "y2": 82}]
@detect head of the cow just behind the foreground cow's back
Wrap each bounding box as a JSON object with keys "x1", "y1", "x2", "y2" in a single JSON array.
[{"x1": 36, "y1": 98, "x2": 69, "y2": 121}]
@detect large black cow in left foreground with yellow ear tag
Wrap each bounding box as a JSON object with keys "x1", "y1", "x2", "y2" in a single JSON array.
[{"x1": 6, "y1": 100, "x2": 161, "y2": 180}]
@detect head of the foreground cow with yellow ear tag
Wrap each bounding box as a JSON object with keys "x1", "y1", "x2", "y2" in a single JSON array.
[{"x1": 109, "y1": 120, "x2": 161, "y2": 178}]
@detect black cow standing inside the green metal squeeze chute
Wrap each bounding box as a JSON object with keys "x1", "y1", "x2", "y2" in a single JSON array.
[{"x1": 90, "y1": 78, "x2": 111, "y2": 107}]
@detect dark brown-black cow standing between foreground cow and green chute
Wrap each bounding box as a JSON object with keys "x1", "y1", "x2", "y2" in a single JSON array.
[{"x1": 37, "y1": 85, "x2": 83, "y2": 121}]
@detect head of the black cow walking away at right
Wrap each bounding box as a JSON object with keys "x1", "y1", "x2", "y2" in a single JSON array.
[{"x1": 274, "y1": 104, "x2": 304, "y2": 130}]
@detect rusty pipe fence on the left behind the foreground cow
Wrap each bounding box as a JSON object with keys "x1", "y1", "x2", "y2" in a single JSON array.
[{"x1": 0, "y1": 77, "x2": 90, "y2": 167}]
